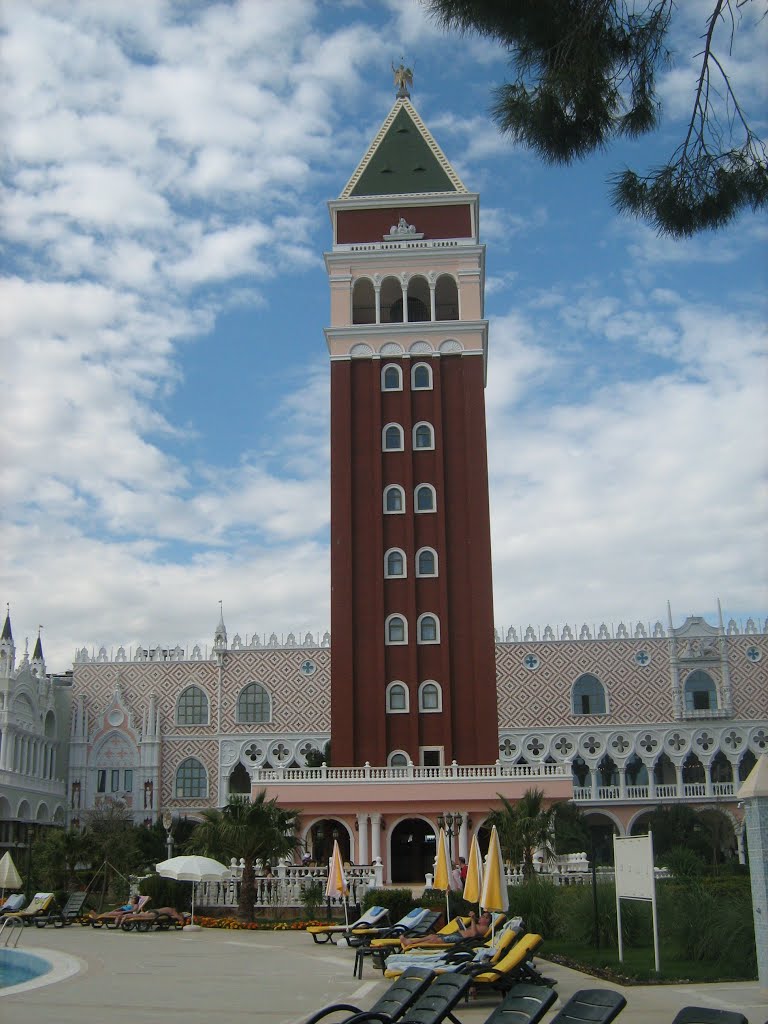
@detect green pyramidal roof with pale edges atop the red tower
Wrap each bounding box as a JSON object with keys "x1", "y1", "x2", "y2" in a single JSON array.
[{"x1": 341, "y1": 99, "x2": 467, "y2": 199}]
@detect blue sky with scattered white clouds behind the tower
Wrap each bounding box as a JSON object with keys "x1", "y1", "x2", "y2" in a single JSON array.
[{"x1": 0, "y1": 0, "x2": 768, "y2": 671}]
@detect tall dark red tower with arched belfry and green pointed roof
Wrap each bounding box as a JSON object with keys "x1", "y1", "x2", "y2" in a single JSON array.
[{"x1": 326, "y1": 89, "x2": 498, "y2": 766}]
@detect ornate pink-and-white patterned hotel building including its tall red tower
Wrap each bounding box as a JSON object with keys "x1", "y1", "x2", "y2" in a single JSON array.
[{"x1": 0, "y1": 89, "x2": 768, "y2": 881}]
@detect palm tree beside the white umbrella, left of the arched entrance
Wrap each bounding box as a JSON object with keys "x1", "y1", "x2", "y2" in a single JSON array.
[{"x1": 184, "y1": 790, "x2": 301, "y2": 921}]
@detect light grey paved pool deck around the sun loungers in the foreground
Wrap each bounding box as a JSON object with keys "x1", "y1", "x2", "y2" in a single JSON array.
[{"x1": 6, "y1": 925, "x2": 768, "y2": 1024}]
